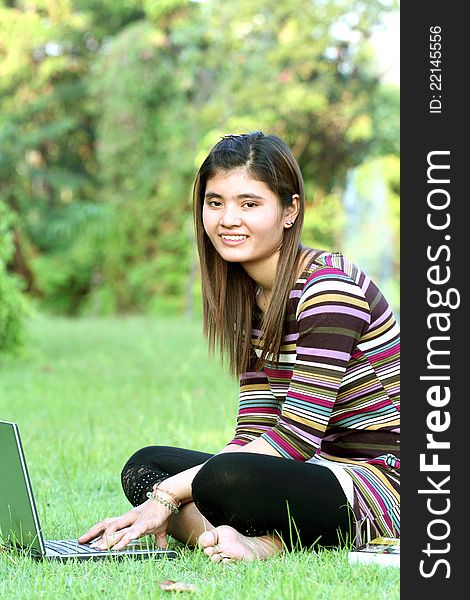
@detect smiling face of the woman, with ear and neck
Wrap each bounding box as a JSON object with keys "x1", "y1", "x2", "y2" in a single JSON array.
[{"x1": 202, "y1": 169, "x2": 298, "y2": 285}]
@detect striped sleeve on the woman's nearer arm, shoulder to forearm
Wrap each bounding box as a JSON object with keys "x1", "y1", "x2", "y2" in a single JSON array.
[{"x1": 262, "y1": 266, "x2": 370, "y2": 461}]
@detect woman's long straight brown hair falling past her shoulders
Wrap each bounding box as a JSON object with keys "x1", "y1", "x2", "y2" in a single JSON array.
[{"x1": 193, "y1": 131, "x2": 306, "y2": 375}]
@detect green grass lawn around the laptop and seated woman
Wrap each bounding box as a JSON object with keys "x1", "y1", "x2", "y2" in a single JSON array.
[{"x1": 0, "y1": 317, "x2": 400, "y2": 600}]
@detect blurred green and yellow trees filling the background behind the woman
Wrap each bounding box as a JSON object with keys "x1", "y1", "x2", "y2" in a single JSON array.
[{"x1": 0, "y1": 0, "x2": 399, "y2": 314}]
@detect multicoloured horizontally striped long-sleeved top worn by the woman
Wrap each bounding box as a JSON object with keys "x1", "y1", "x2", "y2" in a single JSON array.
[{"x1": 231, "y1": 251, "x2": 400, "y2": 540}]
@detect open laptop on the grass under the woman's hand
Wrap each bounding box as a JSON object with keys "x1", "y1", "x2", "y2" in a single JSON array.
[{"x1": 0, "y1": 421, "x2": 178, "y2": 561}]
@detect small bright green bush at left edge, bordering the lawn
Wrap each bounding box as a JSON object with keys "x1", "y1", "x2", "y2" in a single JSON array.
[{"x1": 0, "y1": 199, "x2": 27, "y2": 355}]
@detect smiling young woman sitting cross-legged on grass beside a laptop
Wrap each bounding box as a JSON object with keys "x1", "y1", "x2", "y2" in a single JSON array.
[{"x1": 79, "y1": 132, "x2": 400, "y2": 562}]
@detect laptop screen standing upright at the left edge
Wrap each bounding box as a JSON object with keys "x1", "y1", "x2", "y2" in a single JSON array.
[{"x1": 0, "y1": 421, "x2": 44, "y2": 554}]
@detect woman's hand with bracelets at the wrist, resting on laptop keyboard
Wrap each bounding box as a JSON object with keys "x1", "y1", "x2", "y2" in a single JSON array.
[{"x1": 78, "y1": 499, "x2": 172, "y2": 550}]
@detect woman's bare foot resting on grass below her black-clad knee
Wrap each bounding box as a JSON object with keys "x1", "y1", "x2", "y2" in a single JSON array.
[{"x1": 198, "y1": 525, "x2": 282, "y2": 562}]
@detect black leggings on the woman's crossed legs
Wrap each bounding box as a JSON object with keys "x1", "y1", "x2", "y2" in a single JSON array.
[{"x1": 121, "y1": 446, "x2": 352, "y2": 548}]
